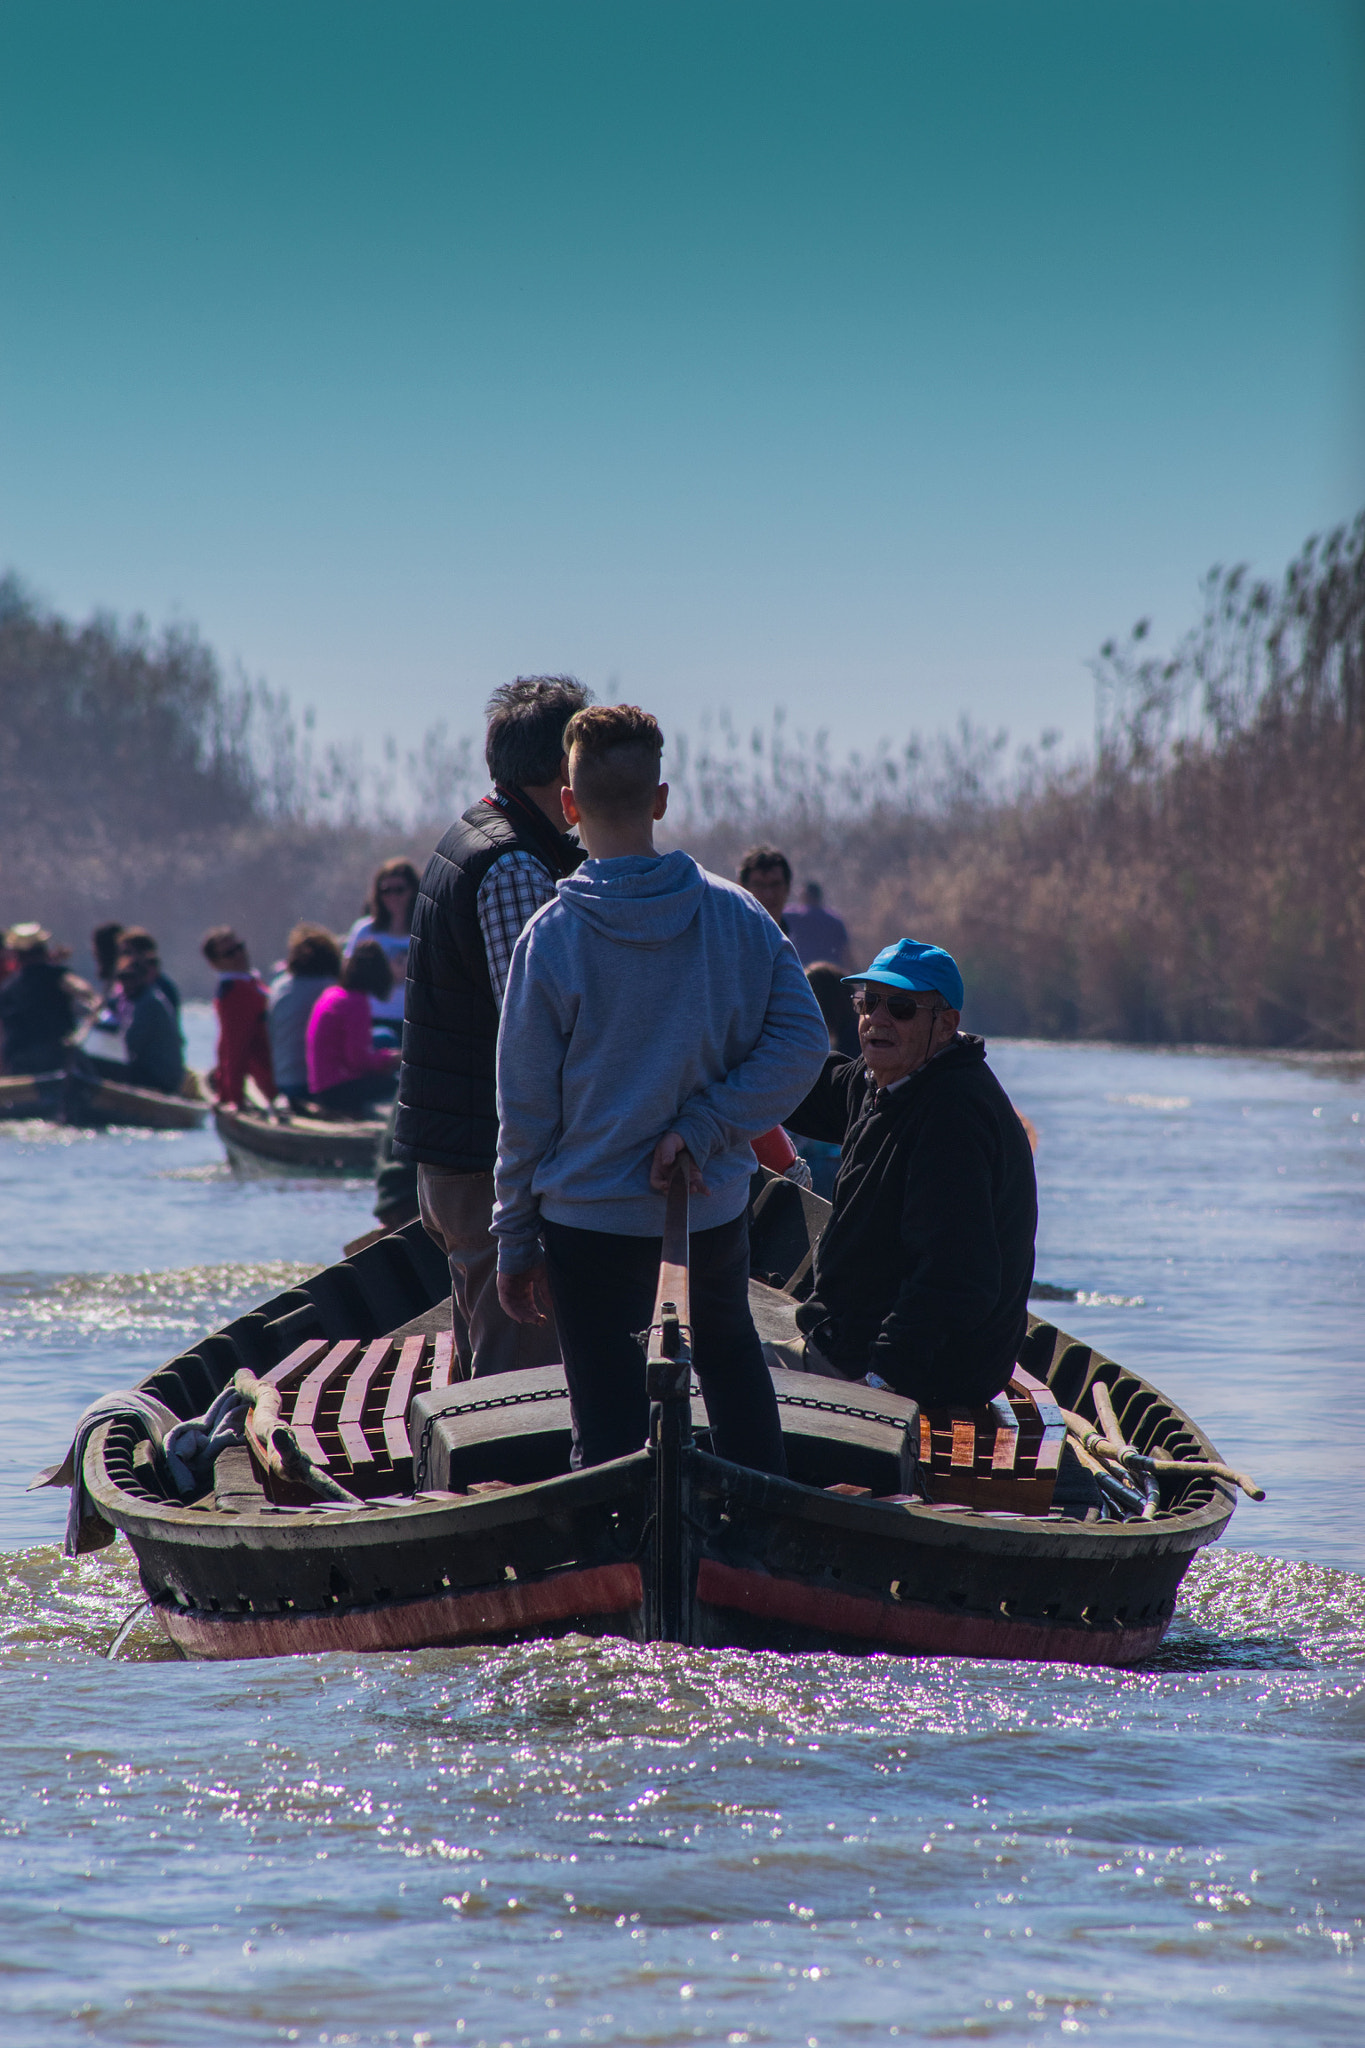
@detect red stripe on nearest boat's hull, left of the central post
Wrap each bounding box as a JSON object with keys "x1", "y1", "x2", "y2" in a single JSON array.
[{"x1": 158, "y1": 1565, "x2": 645, "y2": 1657}]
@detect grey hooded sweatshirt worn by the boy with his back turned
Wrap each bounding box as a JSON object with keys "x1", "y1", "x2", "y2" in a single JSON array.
[{"x1": 493, "y1": 852, "x2": 829, "y2": 1272}]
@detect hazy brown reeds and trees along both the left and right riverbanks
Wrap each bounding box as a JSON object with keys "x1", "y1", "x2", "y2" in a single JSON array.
[{"x1": 0, "y1": 516, "x2": 1365, "y2": 1049}]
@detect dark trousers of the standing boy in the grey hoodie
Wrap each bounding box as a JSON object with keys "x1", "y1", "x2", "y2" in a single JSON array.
[{"x1": 540, "y1": 1214, "x2": 786, "y2": 1473}]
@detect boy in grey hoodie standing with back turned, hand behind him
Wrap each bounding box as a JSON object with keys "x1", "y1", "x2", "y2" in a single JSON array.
[{"x1": 493, "y1": 705, "x2": 829, "y2": 1473}]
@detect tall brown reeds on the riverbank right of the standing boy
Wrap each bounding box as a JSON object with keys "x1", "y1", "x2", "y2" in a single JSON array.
[{"x1": 688, "y1": 514, "x2": 1365, "y2": 1049}]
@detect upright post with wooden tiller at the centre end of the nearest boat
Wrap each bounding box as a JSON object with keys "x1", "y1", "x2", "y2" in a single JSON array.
[{"x1": 645, "y1": 1167, "x2": 692, "y2": 1642}]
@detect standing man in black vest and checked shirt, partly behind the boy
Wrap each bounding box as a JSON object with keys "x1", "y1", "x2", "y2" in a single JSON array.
[{"x1": 393, "y1": 676, "x2": 589, "y2": 1376}]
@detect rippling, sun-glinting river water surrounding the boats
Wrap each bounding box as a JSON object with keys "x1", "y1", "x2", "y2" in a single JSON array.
[{"x1": 0, "y1": 1020, "x2": 1365, "y2": 2048}]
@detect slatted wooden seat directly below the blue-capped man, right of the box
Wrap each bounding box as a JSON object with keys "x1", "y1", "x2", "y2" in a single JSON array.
[{"x1": 919, "y1": 1366, "x2": 1066, "y2": 1516}]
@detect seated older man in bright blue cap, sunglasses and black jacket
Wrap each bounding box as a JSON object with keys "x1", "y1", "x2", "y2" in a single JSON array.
[{"x1": 786, "y1": 938, "x2": 1038, "y2": 1407}]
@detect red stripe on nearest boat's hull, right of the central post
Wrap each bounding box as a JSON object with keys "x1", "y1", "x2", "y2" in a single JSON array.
[{"x1": 696, "y1": 1556, "x2": 1166, "y2": 1665}]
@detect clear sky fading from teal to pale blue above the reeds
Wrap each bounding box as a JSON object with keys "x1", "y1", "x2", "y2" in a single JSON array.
[{"x1": 0, "y1": 0, "x2": 1365, "y2": 765}]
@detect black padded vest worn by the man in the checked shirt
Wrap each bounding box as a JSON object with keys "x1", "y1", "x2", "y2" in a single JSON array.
[{"x1": 393, "y1": 784, "x2": 587, "y2": 1174}]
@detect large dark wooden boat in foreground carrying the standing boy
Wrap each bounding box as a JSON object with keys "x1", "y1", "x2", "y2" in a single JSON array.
[{"x1": 45, "y1": 1178, "x2": 1250, "y2": 1665}]
